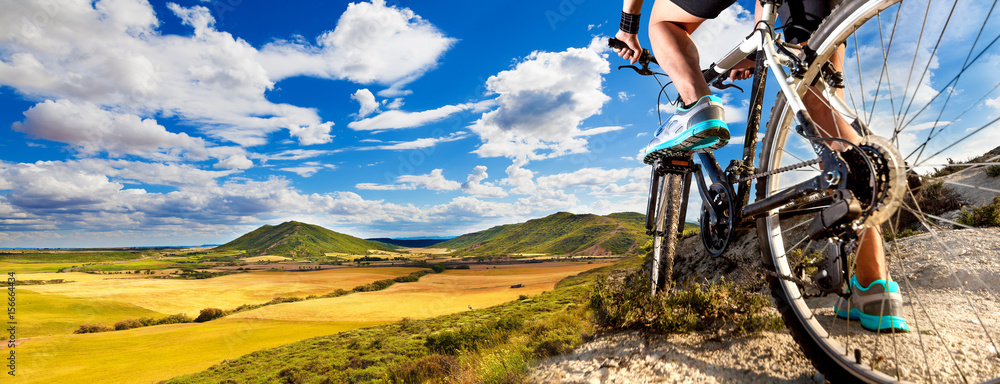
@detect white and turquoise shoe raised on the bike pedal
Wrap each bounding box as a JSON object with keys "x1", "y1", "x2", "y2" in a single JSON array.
[{"x1": 642, "y1": 95, "x2": 729, "y2": 164}]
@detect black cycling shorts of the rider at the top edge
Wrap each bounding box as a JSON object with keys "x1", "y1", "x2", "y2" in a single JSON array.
[{"x1": 670, "y1": 0, "x2": 831, "y2": 44}]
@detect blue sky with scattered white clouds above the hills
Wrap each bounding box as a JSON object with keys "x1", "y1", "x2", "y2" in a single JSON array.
[{"x1": 0, "y1": 0, "x2": 988, "y2": 247}]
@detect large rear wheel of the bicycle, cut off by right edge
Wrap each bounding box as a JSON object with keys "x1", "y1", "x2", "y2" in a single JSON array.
[{"x1": 757, "y1": 0, "x2": 1000, "y2": 383}]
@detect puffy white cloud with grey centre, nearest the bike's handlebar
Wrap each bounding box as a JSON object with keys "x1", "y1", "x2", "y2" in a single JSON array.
[{"x1": 470, "y1": 38, "x2": 610, "y2": 159}]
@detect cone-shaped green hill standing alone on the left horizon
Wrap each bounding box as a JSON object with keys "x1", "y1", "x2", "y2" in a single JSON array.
[{"x1": 215, "y1": 221, "x2": 391, "y2": 257}]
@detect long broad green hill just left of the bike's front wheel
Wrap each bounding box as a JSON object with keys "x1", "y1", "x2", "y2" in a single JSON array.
[{"x1": 435, "y1": 212, "x2": 647, "y2": 256}]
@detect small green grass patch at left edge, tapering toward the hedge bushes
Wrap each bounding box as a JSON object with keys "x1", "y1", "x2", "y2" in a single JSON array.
[{"x1": 16, "y1": 290, "x2": 164, "y2": 338}]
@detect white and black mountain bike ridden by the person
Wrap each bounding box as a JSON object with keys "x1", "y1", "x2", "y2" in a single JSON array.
[{"x1": 609, "y1": 0, "x2": 1000, "y2": 383}]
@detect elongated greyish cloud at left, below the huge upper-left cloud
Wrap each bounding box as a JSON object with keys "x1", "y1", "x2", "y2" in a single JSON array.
[{"x1": 12, "y1": 100, "x2": 207, "y2": 159}]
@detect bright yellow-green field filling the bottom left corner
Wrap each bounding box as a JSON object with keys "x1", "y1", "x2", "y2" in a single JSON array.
[{"x1": 4, "y1": 319, "x2": 377, "y2": 384}]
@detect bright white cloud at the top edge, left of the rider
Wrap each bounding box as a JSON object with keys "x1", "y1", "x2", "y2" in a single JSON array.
[{"x1": 260, "y1": 0, "x2": 455, "y2": 87}]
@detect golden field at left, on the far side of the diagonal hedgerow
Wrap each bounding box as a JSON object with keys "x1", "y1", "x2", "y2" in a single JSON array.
[{"x1": 19, "y1": 267, "x2": 417, "y2": 316}]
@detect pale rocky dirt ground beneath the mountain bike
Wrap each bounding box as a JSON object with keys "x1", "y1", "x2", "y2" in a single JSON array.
[{"x1": 530, "y1": 226, "x2": 1000, "y2": 383}]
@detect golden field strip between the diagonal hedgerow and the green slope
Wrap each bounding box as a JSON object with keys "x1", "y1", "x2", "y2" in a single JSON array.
[{"x1": 229, "y1": 263, "x2": 608, "y2": 322}]
